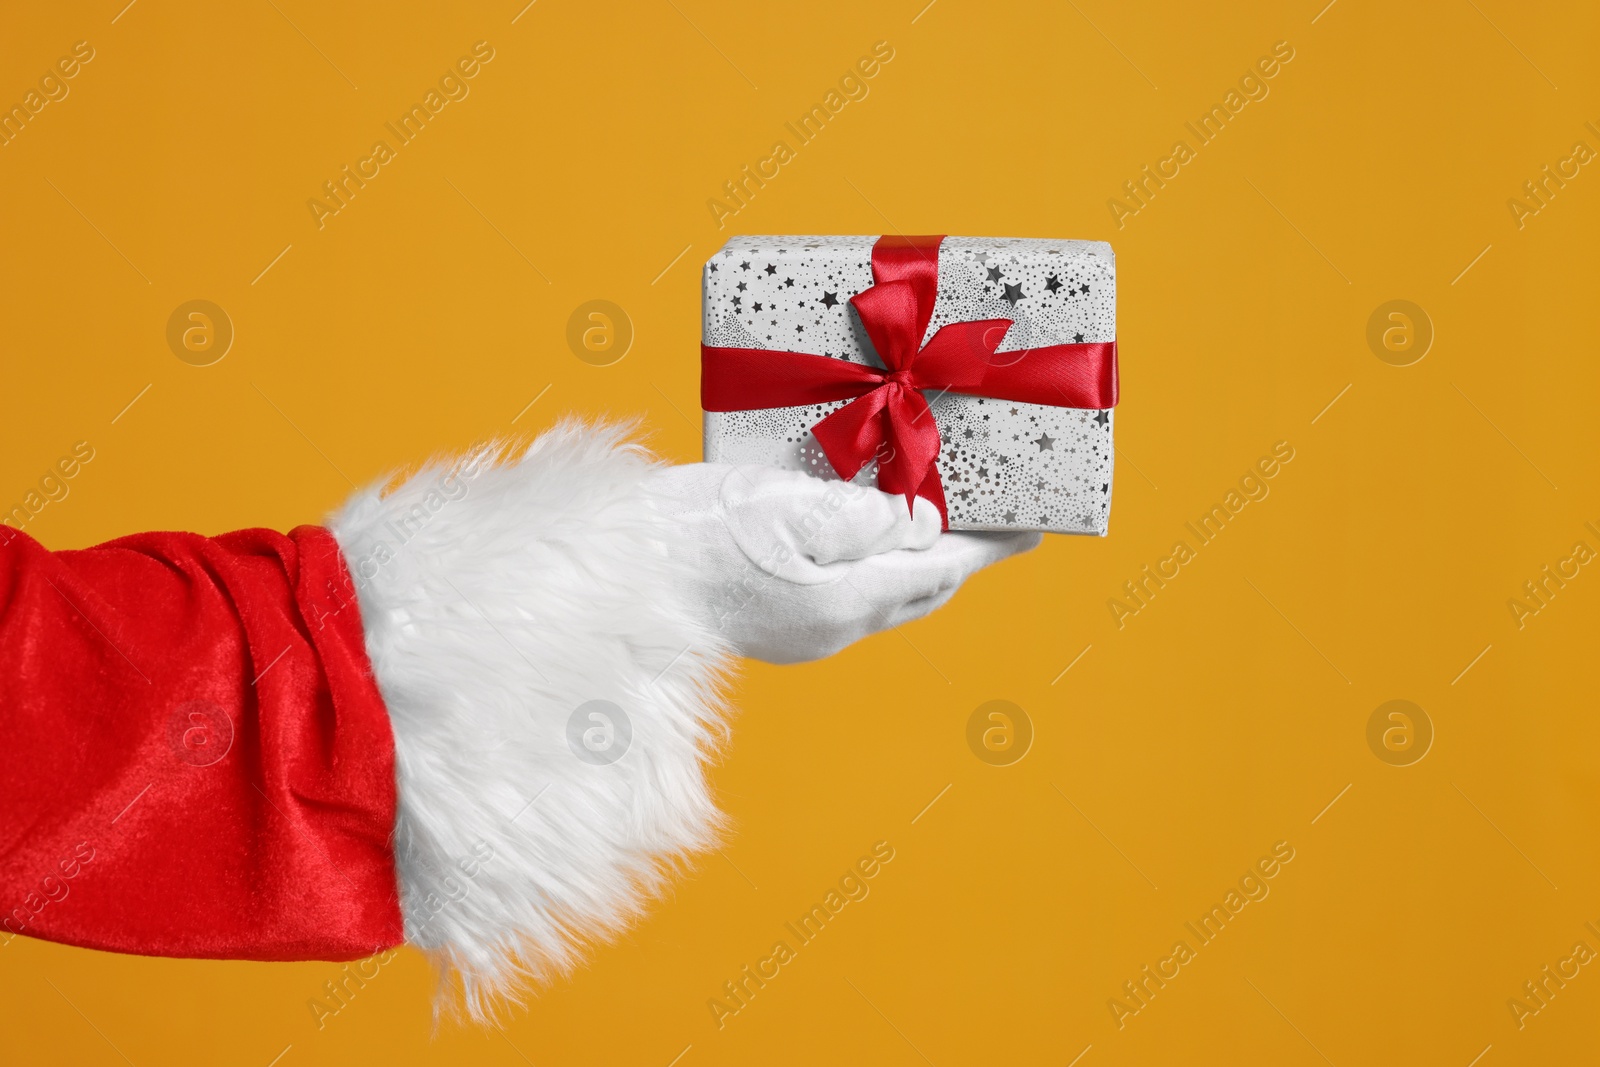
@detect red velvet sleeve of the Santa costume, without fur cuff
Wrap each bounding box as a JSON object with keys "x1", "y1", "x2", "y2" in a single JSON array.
[{"x1": 0, "y1": 526, "x2": 403, "y2": 960}]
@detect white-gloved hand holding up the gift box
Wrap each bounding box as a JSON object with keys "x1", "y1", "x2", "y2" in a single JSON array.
[{"x1": 646, "y1": 464, "x2": 1040, "y2": 664}]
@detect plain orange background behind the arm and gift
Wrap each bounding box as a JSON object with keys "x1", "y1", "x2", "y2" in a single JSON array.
[{"x1": 0, "y1": 0, "x2": 1600, "y2": 1067}]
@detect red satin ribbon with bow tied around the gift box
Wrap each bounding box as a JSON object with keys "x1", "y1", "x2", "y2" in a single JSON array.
[{"x1": 701, "y1": 235, "x2": 1117, "y2": 526}]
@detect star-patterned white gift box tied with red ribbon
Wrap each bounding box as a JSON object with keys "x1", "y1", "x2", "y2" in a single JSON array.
[{"x1": 701, "y1": 237, "x2": 1117, "y2": 536}]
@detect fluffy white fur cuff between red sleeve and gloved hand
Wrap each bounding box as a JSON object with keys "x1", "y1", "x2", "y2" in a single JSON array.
[{"x1": 330, "y1": 422, "x2": 730, "y2": 1019}]
